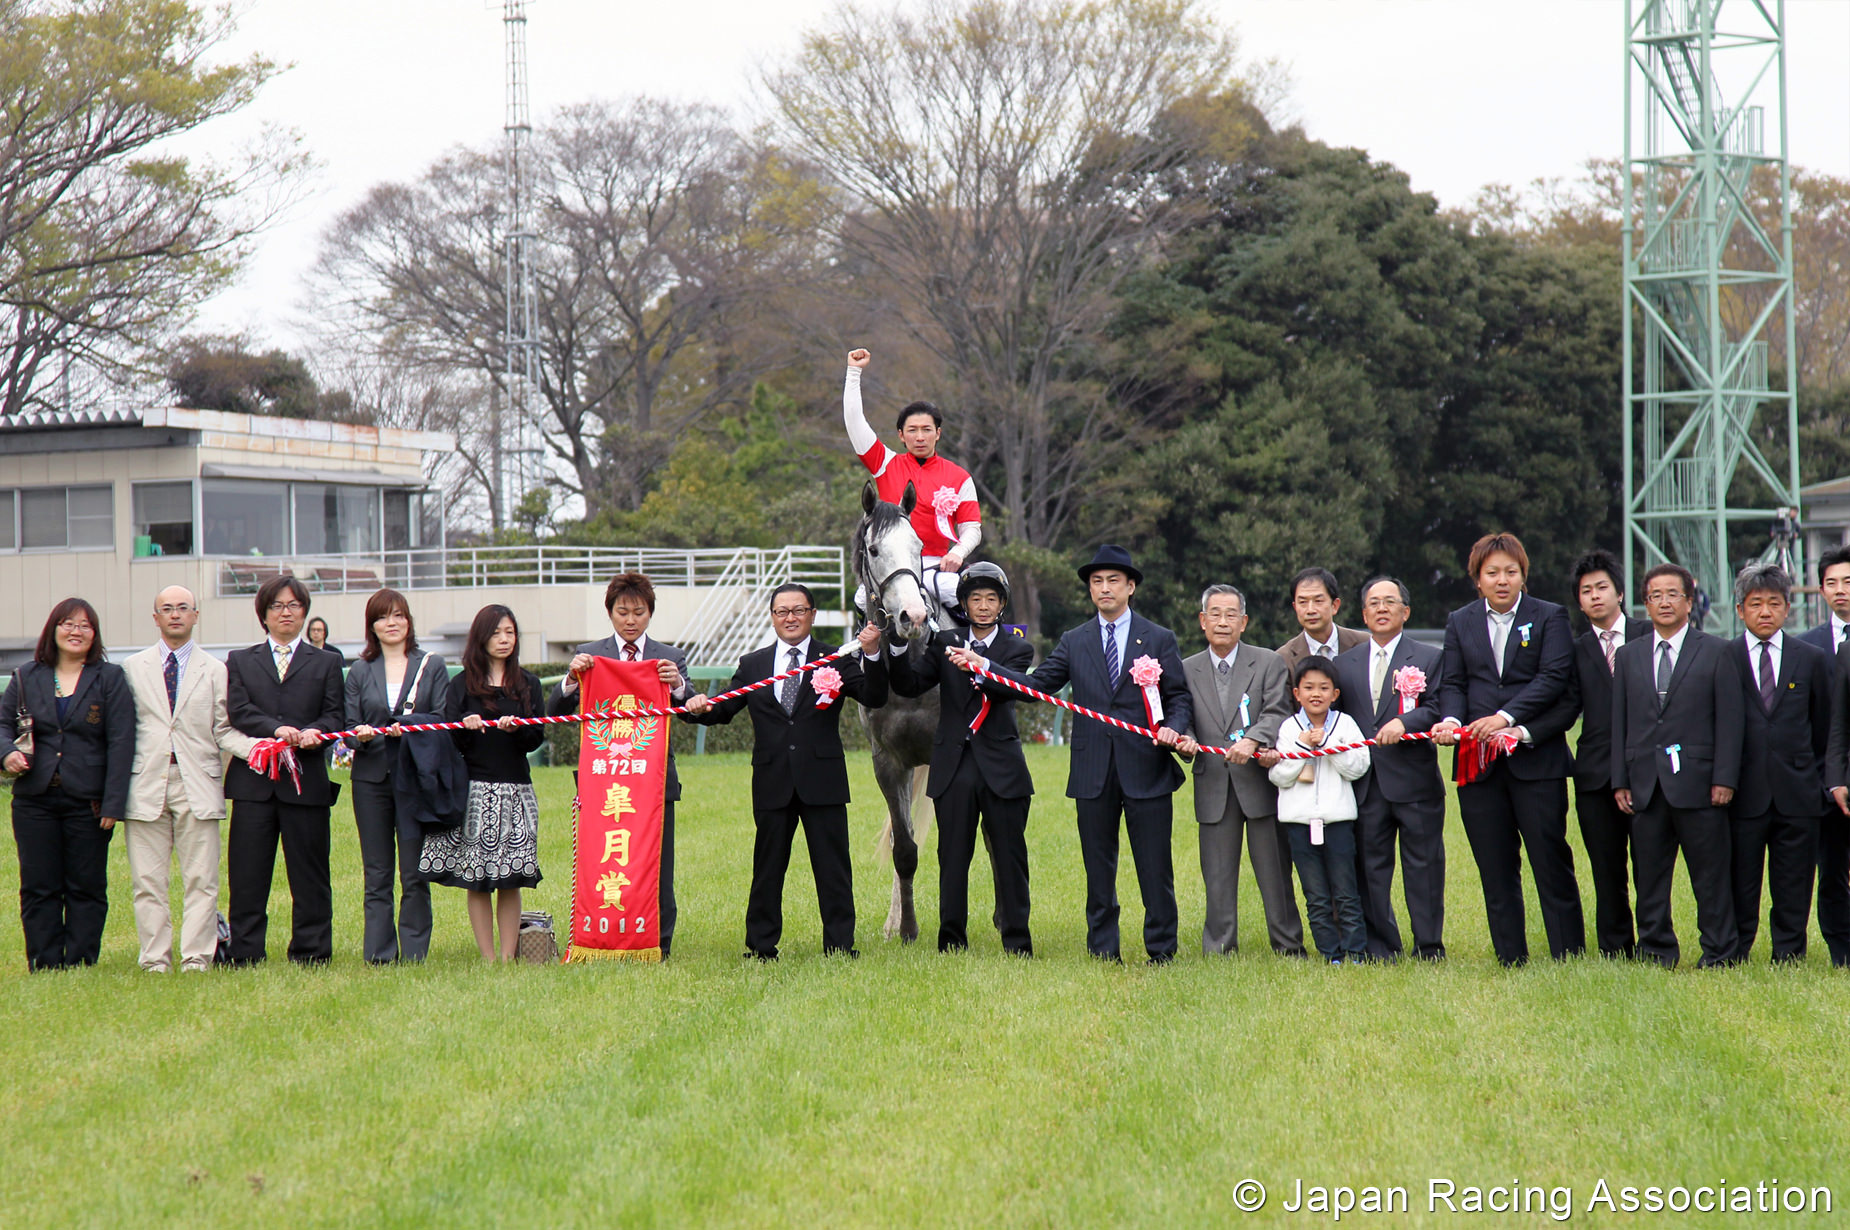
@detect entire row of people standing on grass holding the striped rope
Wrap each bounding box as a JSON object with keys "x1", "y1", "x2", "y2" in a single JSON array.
[{"x1": 0, "y1": 535, "x2": 1850, "y2": 969}]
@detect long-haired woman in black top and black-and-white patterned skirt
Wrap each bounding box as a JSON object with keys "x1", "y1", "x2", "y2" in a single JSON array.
[{"x1": 418, "y1": 605, "x2": 546, "y2": 962}]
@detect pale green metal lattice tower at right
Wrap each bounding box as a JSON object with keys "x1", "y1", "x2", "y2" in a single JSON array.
[{"x1": 1624, "y1": 0, "x2": 1804, "y2": 631}]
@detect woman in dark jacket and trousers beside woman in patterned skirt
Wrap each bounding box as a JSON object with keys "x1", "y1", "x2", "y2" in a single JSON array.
[{"x1": 346, "y1": 590, "x2": 450, "y2": 964}]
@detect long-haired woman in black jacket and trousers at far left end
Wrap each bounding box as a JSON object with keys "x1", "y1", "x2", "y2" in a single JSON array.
[{"x1": 0, "y1": 597, "x2": 135, "y2": 969}]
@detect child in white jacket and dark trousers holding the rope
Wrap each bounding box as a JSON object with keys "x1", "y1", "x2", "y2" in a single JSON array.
[{"x1": 1254, "y1": 655, "x2": 1369, "y2": 966}]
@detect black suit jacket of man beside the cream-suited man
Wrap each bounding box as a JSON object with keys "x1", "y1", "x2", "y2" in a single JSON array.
[{"x1": 226, "y1": 638, "x2": 346, "y2": 806}]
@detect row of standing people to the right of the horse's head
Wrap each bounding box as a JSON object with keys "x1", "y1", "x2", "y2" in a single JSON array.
[{"x1": 892, "y1": 535, "x2": 1850, "y2": 966}]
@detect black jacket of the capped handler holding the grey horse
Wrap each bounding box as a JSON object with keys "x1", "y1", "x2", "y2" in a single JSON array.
[{"x1": 886, "y1": 629, "x2": 1034, "y2": 799}]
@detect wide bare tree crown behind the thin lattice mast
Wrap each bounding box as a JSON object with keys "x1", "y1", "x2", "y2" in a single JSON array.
[{"x1": 313, "y1": 98, "x2": 821, "y2": 527}]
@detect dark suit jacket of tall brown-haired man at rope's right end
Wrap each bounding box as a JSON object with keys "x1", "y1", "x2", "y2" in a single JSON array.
[{"x1": 1439, "y1": 594, "x2": 1574, "y2": 782}]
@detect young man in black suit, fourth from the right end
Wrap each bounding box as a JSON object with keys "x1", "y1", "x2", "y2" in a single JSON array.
[{"x1": 1571, "y1": 549, "x2": 1650, "y2": 958}]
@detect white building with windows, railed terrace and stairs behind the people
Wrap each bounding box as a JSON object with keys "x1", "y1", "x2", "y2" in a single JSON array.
[{"x1": 0, "y1": 409, "x2": 844, "y2": 668}]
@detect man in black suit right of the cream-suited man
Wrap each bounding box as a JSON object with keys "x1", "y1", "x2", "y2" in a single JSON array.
[{"x1": 226, "y1": 577, "x2": 346, "y2": 966}]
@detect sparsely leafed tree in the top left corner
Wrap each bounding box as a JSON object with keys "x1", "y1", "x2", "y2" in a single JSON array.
[{"x1": 0, "y1": 0, "x2": 303, "y2": 414}]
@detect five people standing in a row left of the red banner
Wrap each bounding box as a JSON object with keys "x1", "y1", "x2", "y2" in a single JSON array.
[{"x1": 0, "y1": 577, "x2": 544, "y2": 971}]
